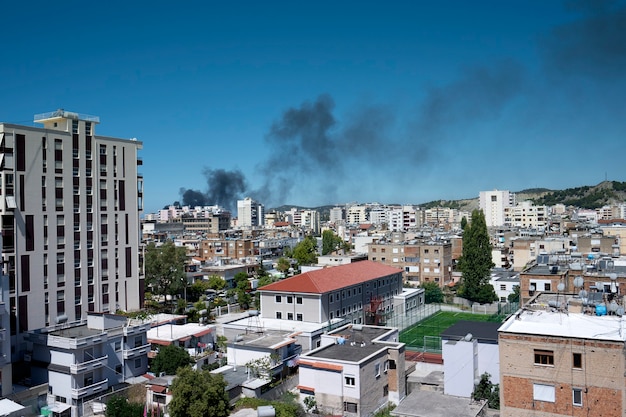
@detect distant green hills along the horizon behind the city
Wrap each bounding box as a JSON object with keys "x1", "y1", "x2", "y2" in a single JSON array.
[{"x1": 272, "y1": 181, "x2": 626, "y2": 216}]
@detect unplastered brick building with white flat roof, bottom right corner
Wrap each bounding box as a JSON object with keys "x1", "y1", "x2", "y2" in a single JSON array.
[{"x1": 499, "y1": 293, "x2": 626, "y2": 417}]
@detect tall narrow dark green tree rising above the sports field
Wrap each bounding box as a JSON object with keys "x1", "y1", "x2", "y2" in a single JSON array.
[{"x1": 459, "y1": 210, "x2": 498, "y2": 304}]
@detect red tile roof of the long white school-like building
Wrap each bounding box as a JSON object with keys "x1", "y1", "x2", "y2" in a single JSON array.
[{"x1": 259, "y1": 261, "x2": 402, "y2": 294}]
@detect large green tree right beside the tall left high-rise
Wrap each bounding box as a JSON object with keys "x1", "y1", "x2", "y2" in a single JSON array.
[{"x1": 145, "y1": 241, "x2": 187, "y2": 306}]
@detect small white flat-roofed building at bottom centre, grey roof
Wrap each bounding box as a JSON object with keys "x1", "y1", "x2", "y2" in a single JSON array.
[{"x1": 298, "y1": 324, "x2": 406, "y2": 417}]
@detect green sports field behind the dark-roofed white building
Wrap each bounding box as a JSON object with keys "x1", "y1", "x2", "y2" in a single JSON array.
[{"x1": 400, "y1": 311, "x2": 500, "y2": 351}]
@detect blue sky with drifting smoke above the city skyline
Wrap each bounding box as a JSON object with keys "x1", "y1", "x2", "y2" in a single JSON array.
[{"x1": 0, "y1": 0, "x2": 626, "y2": 212}]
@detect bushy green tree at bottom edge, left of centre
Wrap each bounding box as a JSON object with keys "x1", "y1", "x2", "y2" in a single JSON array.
[{"x1": 168, "y1": 368, "x2": 230, "y2": 417}]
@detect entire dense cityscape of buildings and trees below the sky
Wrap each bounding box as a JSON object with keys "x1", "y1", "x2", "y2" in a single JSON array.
[{"x1": 0, "y1": 110, "x2": 626, "y2": 417}]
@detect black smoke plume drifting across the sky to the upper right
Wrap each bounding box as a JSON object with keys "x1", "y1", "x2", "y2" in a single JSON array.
[{"x1": 182, "y1": 1, "x2": 626, "y2": 207}]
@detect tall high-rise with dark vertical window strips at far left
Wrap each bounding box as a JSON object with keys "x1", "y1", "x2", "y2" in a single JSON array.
[{"x1": 0, "y1": 110, "x2": 144, "y2": 384}]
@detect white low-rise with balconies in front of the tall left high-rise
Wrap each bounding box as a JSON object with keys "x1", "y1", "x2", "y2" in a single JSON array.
[{"x1": 26, "y1": 313, "x2": 150, "y2": 417}]
